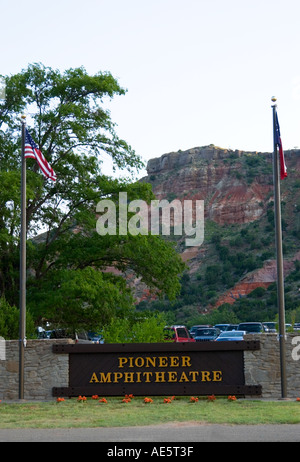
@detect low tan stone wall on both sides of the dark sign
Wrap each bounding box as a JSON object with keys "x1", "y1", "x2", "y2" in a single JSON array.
[{"x1": 0, "y1": 332, "x2": 300, "y2": 400}]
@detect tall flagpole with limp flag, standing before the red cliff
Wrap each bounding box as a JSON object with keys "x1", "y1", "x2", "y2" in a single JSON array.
[{"x1": 272, "y1": 97, "x2": 287, "y2": 399}]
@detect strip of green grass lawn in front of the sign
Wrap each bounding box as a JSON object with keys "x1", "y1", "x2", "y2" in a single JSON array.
[{"x1": 0, "y1": 396, "x2": 300, "y2": 428}]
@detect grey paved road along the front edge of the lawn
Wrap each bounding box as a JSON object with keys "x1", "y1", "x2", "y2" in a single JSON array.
[{"x1": 0, "y1": 423, "x2": 300, "y2": 443}]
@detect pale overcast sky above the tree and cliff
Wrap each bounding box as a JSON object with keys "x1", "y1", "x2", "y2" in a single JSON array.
[{"x1": 0, "y1": 0, "x2": 300, "y2": 177}]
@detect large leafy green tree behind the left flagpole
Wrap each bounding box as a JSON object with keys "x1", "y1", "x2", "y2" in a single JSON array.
[{"x1": 0, "y1": 64, "x2": 183, "y2": 327}]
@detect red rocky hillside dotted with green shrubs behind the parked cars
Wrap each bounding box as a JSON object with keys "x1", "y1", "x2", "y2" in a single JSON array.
[{"x1": 141, "y1": 145, "x2": 300, "y2": 321}]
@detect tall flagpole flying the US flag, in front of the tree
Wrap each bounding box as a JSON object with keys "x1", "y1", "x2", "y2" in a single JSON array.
[{"x1": 19, "y1": 116, "x2": 26, "y2": 399}]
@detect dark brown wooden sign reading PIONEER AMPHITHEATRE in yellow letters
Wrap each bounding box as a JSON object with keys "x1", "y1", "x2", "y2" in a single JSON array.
[{"x1": 53, "y1": 341, "x2": 261, "y2": 396}]
